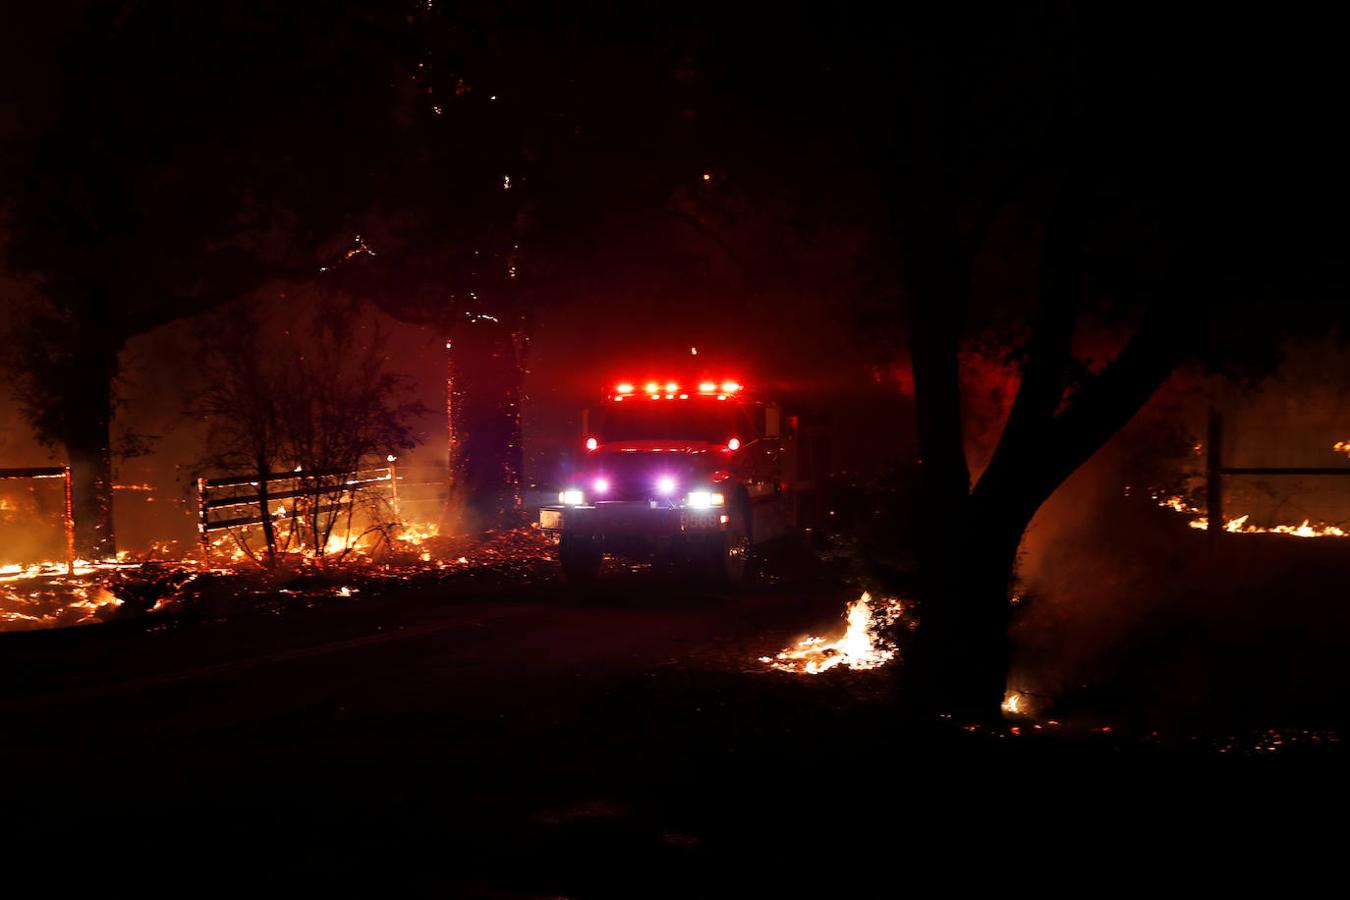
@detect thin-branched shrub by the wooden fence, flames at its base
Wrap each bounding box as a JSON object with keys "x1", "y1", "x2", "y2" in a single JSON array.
[{"x1": 193, "y1": 301, "x2": 425, "y2": 567}]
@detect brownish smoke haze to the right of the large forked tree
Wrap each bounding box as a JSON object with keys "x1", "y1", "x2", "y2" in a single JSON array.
[{"x1": 1010, "y1": 340, "x2": 1350, "y2": 730}]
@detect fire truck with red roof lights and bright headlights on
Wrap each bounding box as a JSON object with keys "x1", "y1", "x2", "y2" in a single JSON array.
[{"x1": 539, "y1": 381, "x2": 819, "y2": 584}]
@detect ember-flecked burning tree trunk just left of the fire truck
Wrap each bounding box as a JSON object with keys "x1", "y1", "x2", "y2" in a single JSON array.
[{"x1": 446, "y1": 316, "x2": 525, "y2": 530}]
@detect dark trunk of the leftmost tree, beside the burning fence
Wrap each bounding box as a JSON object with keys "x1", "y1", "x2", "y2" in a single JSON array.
[{"x1": 62, "y1": 360, "x2": 117, "y2": 560}]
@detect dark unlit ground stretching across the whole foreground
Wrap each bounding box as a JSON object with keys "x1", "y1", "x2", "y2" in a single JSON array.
[{"x1": 0, "y1": 558, "x2": 1350, "y2": 897}]
